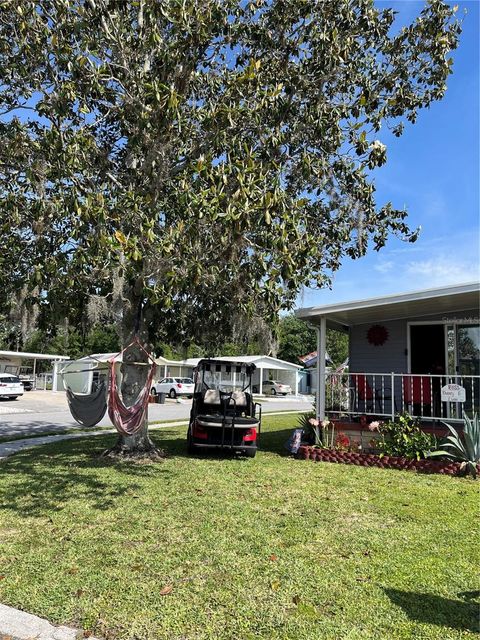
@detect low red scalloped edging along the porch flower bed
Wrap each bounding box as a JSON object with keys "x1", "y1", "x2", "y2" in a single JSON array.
[{"x1": 297, "y1": 445, "x2": 480, "y2": 476}]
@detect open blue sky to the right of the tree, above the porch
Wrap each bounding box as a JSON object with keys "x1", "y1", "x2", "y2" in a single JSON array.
[{"x1": 298, "y1": 0, "x2": 480, "y2": 306}]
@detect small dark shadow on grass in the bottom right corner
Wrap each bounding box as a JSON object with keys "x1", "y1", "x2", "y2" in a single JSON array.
[{"x1": 384, "y1": 588, "x2": 480, "y2": 633}]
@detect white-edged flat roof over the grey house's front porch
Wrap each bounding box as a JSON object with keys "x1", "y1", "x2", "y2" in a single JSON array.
[{"x1": 295, "y1": 282, "x2": 480, "y2": 328}]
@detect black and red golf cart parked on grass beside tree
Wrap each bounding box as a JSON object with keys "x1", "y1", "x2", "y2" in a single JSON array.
[{"x1": 187, "y1": 360, "x2": 262, "y2": 458}]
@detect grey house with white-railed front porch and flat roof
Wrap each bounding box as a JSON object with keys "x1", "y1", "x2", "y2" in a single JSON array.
[{"x1": 296, "y1": 282, "x2": 480, "y2": 422}]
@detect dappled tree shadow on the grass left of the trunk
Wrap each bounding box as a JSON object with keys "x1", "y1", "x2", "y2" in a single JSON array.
[{"x1": 0, "y1": 436, "x2": 170, "y2": 516}]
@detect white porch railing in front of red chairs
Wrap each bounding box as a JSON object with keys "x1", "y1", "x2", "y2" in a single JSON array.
[{"x1": 325, "y1": 373, "x2": 480, "y2": 421}]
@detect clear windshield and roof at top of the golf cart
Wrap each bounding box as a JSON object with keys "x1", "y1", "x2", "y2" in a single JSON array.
[{"x1": 195, "y1": 360, "x2": 254, "y2": 393}]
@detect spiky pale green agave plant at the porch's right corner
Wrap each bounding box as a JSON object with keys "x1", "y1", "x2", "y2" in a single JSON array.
[{"x1": 428, "y1": 413, "x2": 480, "y2": 478}]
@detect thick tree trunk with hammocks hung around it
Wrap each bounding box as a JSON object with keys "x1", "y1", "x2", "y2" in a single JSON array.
[{"x1": 106, "y1": 286, "x2": 165, "y2": 460}]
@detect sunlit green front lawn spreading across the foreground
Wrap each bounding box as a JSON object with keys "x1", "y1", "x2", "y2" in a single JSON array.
[{"x1": 0, "y1": 415, "x2": 480, "y2": 640}]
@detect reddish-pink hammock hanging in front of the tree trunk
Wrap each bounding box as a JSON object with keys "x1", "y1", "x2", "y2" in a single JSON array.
[{"x1": 108, "y1": 338, "x2": 157, "y2": 436}]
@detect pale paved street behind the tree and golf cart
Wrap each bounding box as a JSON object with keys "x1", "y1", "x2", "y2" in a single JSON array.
[{"x1": 0, "y1": 391, "x2": 312, "y2": 438}]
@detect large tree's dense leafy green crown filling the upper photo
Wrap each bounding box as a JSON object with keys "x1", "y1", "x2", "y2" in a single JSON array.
[{"x1": 0, "y1": 0, "x2": 460, "y2": 456}]
